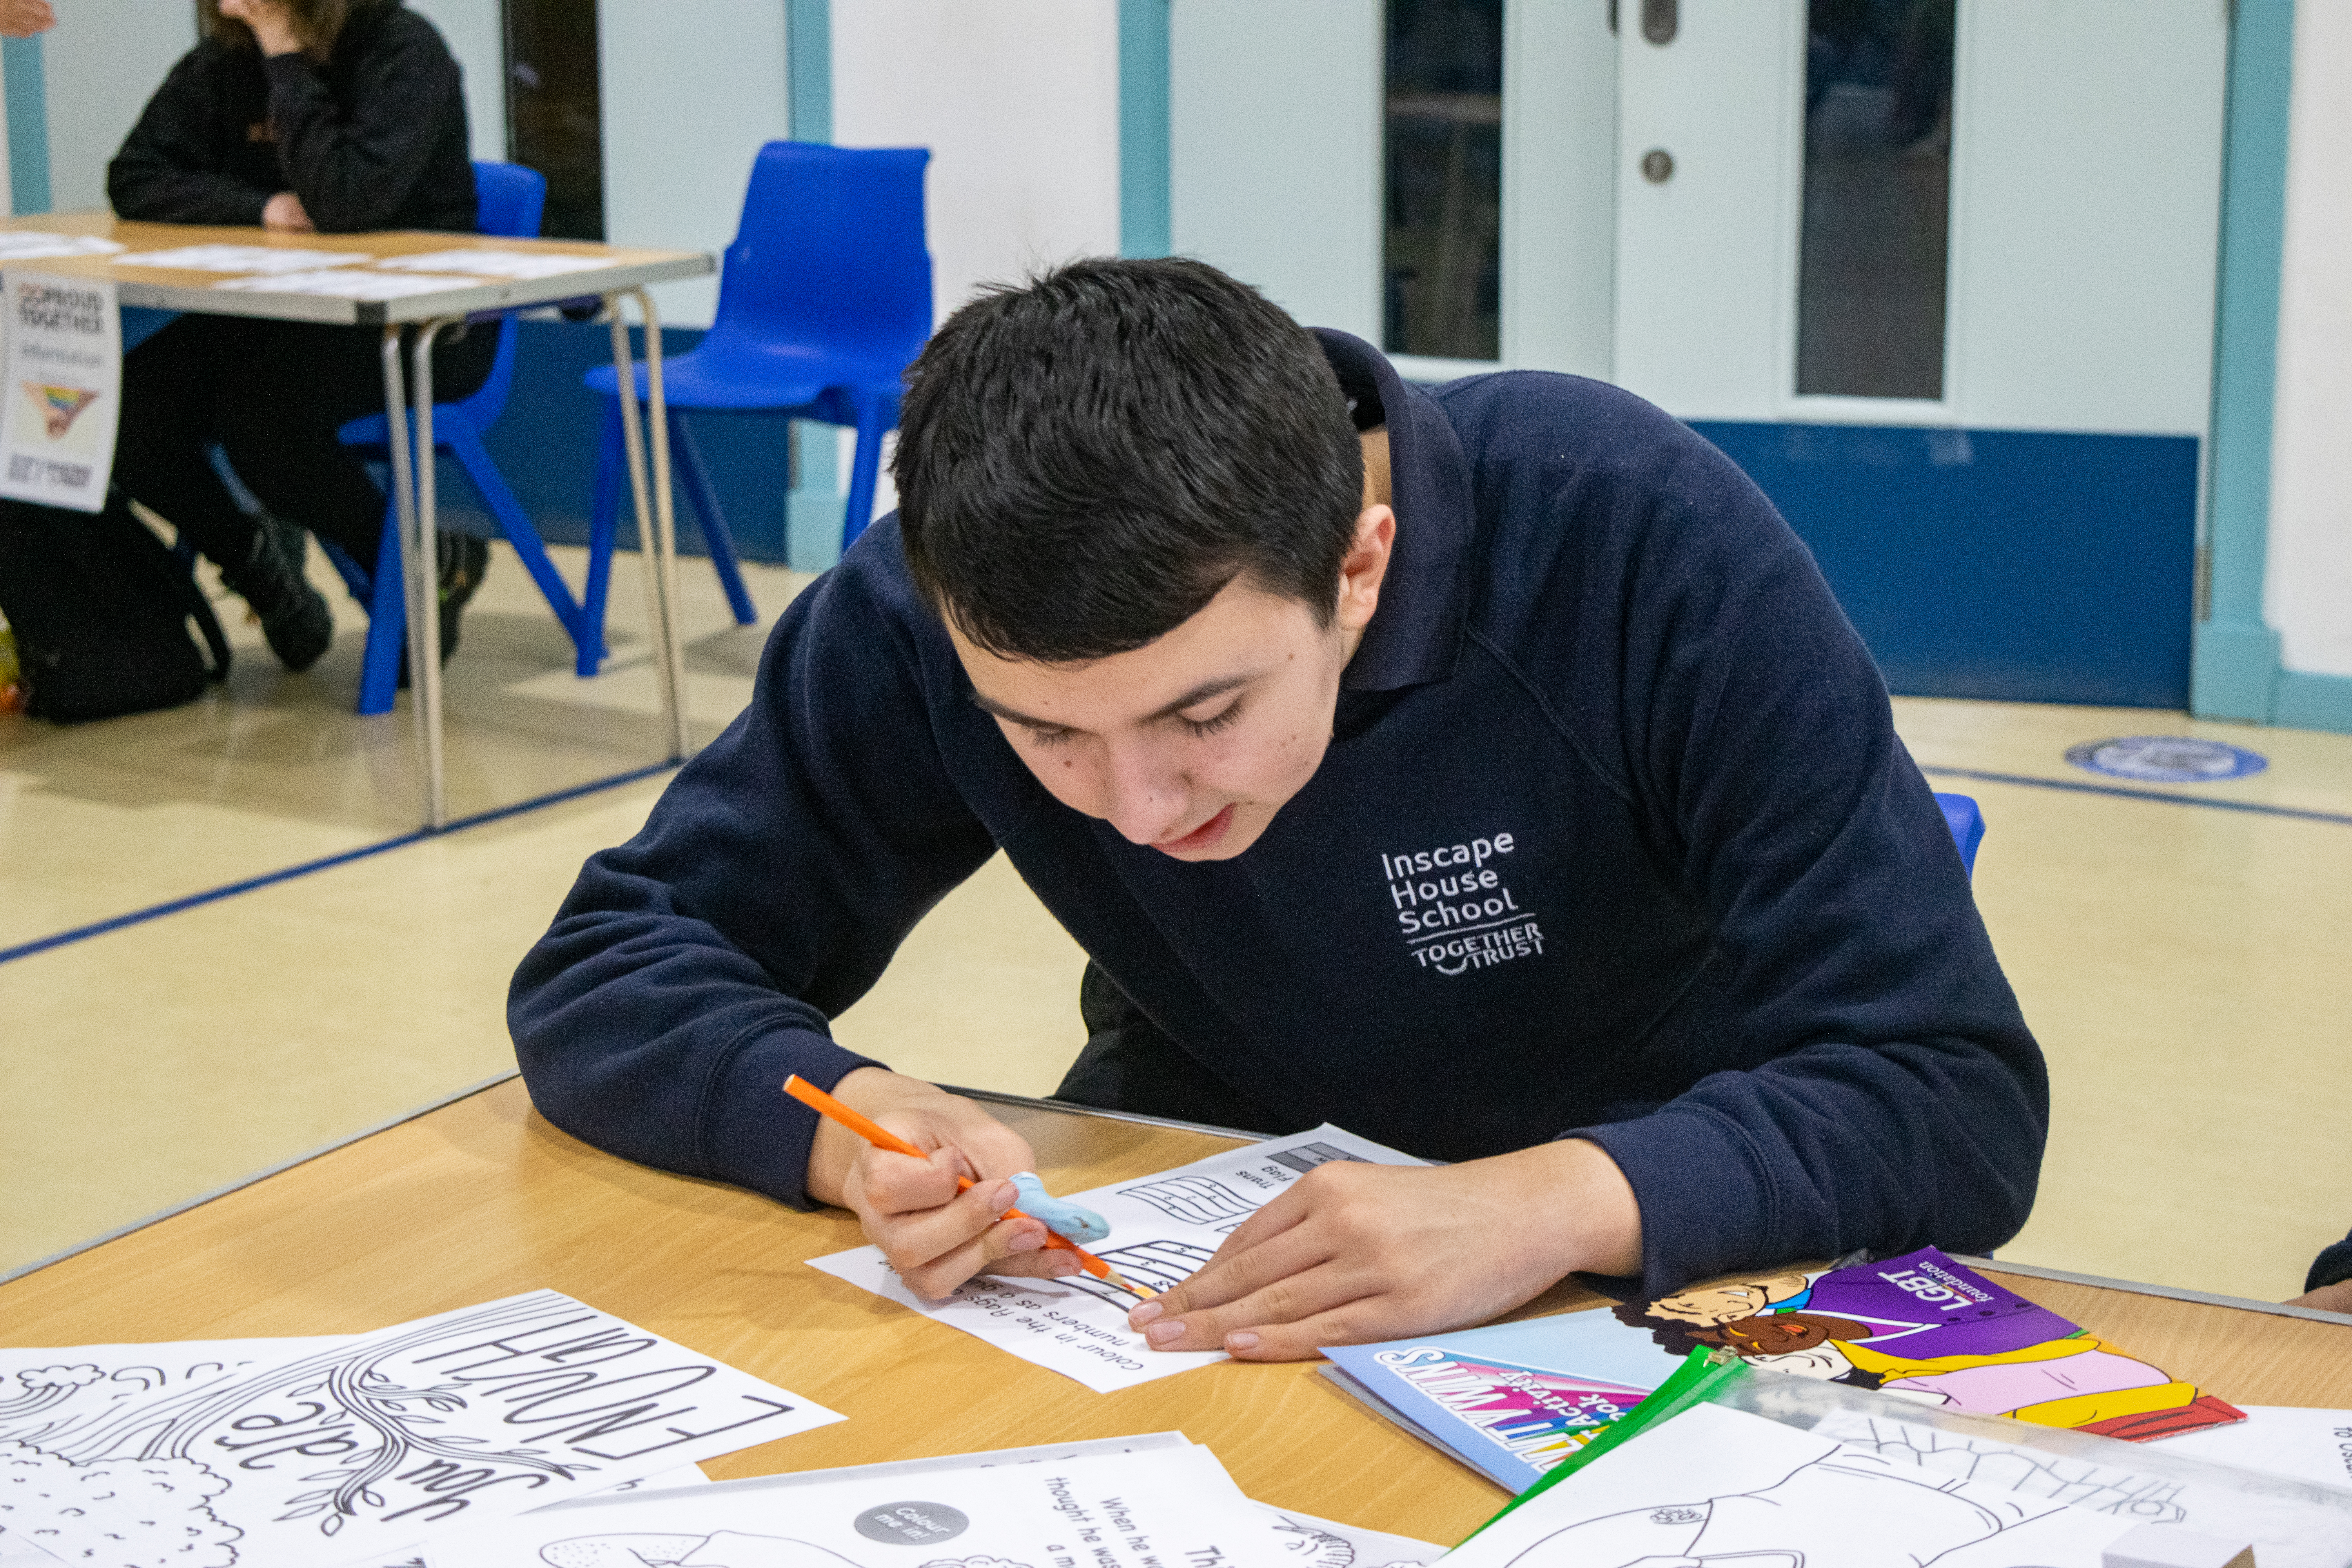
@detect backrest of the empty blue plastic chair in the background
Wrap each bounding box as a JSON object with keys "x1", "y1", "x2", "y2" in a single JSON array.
[{"x1": 710, "y1": 141, "x2": 931, "y2": 367}]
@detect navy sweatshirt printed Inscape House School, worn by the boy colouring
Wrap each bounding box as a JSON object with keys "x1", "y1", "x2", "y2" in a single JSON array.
[{"x1": 508, "y1": 332, "x2": 2049, "y2": 1295}]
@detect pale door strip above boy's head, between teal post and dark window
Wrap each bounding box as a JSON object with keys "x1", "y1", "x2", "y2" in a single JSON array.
[{"x1": 1171, "y1": 0, "x2": 1374, "y2": 343}]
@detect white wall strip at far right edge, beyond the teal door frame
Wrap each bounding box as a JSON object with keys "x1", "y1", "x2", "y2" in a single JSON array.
[{"x1": 2263, "y1": 0, "x2": 2352, "y2": 675}]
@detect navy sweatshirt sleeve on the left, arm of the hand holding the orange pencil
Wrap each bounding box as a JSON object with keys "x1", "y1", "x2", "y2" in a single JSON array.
[{"x1": 508, "y1": 534, "x2": 995, "y2": 1206}]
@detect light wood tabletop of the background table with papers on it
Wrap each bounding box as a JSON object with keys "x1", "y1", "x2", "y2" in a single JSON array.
[{"x1": 0, "y1": 212, "x2": 715, "y2": 327}]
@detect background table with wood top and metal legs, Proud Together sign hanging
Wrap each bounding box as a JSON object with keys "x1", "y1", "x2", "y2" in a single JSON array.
[{"x1": 0, "y1": 212, "x2": 715, "y2": 828}]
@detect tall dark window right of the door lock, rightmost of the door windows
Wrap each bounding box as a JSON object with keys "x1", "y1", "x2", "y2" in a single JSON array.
[{"x1": 1797, "y1": 0, "x2": 1955, "y2": 397}]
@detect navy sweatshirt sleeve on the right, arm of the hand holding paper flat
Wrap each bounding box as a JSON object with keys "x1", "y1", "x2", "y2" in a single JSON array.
[{"x1": 1573, "y1": 411, "x2": 2049, "y2": 1295}]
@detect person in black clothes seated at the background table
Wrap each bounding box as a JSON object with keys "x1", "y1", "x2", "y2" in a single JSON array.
[{"x1": 106, "y1": 0, "x2": 496, "y2": 670}]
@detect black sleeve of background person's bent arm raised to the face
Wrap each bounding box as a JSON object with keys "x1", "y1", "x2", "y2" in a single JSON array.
[{"x1": 263, "y1": 28, "x2": 466, "y2": 235}]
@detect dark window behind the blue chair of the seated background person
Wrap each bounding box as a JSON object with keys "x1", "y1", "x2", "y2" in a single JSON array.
[{"x1": 506, "y1": 0, "x2": 604, "y2": 240}]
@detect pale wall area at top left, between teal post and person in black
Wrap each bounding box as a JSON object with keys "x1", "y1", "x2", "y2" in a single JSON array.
[{"x1": 40, "y1": 0, "x2": 195, "y2": 212}]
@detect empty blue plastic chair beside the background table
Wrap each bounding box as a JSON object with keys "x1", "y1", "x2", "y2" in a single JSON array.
[{"x1": 576, "y1": 141, "x2": 931, "y2": 675}]
